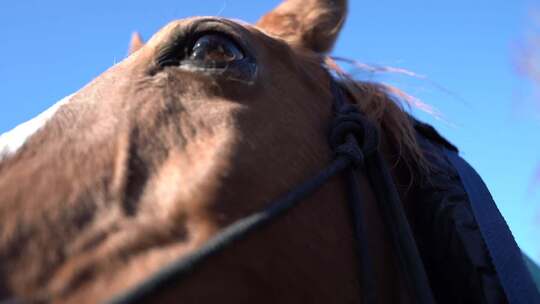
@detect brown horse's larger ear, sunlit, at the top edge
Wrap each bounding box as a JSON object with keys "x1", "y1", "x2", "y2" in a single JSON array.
[{"x1": 257, "y1": 0, "x2": 347, "y2": 53}]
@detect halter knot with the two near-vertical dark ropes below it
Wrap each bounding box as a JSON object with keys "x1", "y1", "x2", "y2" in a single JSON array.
[{"x1": 330, "y1": 81, "x2": 435, "y2": 304}]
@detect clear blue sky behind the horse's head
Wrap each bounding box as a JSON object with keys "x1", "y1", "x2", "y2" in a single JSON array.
[{"x1": 0, "y1": 0, "x2": 540, "y2": 261}]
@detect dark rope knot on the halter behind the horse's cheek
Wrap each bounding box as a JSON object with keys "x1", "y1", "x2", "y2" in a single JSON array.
[{"x1": 330, "y1": 105, "x2": 379, "y2": 167}]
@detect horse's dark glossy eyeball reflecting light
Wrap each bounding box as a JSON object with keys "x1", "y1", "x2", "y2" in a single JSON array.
[{"x1": 189, "y1": 34, "x2": 244, "y2": 66}]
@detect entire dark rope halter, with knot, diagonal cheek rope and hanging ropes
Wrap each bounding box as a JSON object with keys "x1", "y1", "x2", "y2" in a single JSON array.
[{"x1": 109, "y1": 78, "x2": 435, "y2": 304}]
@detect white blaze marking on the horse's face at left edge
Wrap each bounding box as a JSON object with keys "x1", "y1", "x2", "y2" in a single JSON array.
[{"x1": 0, "y1": 95, "x2": 73, "y2": 161}]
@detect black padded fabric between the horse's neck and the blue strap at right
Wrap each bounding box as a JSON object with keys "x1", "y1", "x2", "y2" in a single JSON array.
[{"x1": 411, "y1": 122, "x2": 507, "y2": 304}]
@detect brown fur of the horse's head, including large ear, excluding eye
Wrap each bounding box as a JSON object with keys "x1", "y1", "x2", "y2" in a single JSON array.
[{"x1": 0, "y1": 1, "x2": 421, "y2": 303}]
